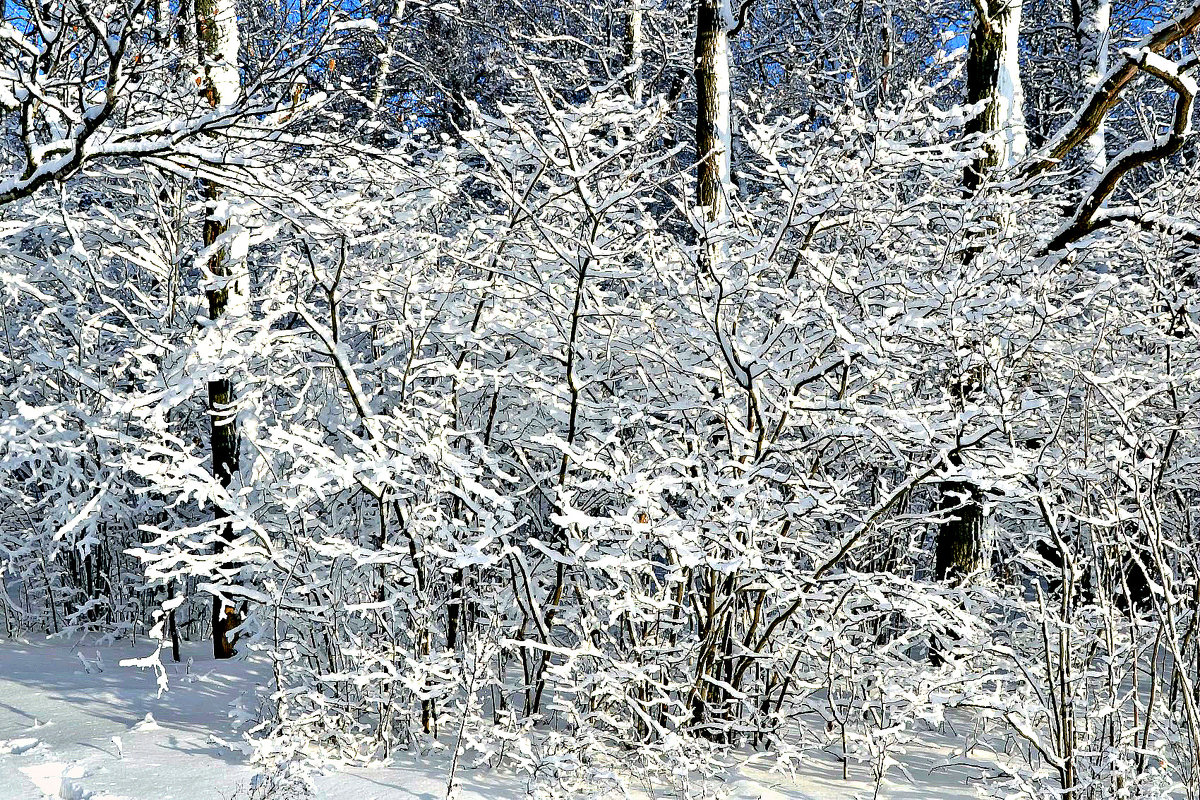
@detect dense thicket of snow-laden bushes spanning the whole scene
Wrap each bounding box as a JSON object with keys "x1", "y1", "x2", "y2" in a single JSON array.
[{"x1": 2, "y1": 26, "x2": 1200, "y2": 799}]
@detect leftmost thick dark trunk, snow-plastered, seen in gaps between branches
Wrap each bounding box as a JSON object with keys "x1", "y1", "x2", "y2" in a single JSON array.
[{"x1": 196, "y1": 0, "x2": 241, "y2": 658}]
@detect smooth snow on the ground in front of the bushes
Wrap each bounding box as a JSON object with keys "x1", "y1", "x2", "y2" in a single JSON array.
[{"x1": 0, "y1": 640, "x2": 993, "y2": 800}]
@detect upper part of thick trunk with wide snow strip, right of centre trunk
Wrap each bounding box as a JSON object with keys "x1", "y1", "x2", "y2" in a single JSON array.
[{"x1": 965, "y1": 0, "x2": 1028, "y2": 192}]
